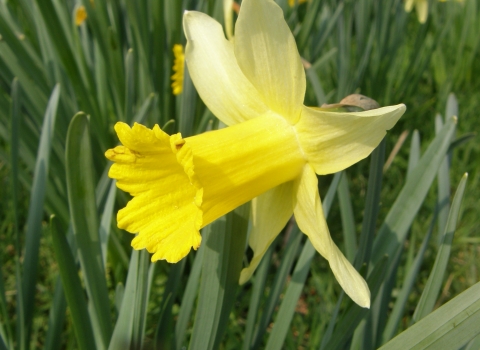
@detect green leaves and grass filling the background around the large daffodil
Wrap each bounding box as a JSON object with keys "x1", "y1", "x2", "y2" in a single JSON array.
[{"x1": 0, "y1": 0, "x2": 480, "y2": 349}]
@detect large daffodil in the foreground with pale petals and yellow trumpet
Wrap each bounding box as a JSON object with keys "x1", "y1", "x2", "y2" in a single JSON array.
[{"x1": 106, "y1": 0, "x2": 405, "y2": 307}]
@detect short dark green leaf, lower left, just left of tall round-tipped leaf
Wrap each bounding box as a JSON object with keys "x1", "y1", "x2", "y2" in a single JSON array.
[{"x1": 50, "y1": 216, "x2": 96, "y2": 350}]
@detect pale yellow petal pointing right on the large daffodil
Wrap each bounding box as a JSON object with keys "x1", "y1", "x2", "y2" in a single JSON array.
[{"x1": 295, "y1": 104, "x2": 406, "y2": 175}]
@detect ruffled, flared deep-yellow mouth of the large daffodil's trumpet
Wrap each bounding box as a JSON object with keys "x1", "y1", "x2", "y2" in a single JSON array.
[{"x1": 105, "y1": 123, "x2": 203, "y2": 262}]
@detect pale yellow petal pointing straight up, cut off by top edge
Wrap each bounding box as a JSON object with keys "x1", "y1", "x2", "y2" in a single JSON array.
[{"x1": 235, "y1": 0, "x2": 306, "y2": 124}]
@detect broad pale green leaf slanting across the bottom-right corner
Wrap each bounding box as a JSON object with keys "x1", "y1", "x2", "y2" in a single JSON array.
[{"x1": 380, "y1": 282, "x2": 480, "y2": 350}]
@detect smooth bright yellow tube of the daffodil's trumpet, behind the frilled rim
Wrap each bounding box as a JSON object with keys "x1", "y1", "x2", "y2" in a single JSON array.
[{"x1": 185, "y1": 114, "x2": 305, "y2": 225}]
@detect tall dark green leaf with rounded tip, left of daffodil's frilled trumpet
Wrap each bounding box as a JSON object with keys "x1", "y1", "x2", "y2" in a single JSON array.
[{"x1": 65, "y1": 112, "x2": 112, "y2": 349}]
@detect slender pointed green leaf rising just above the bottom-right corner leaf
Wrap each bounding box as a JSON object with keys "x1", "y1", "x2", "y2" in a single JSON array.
[{"x1": 412, "y1": 174, "x2": 468, "y2": 322}]
